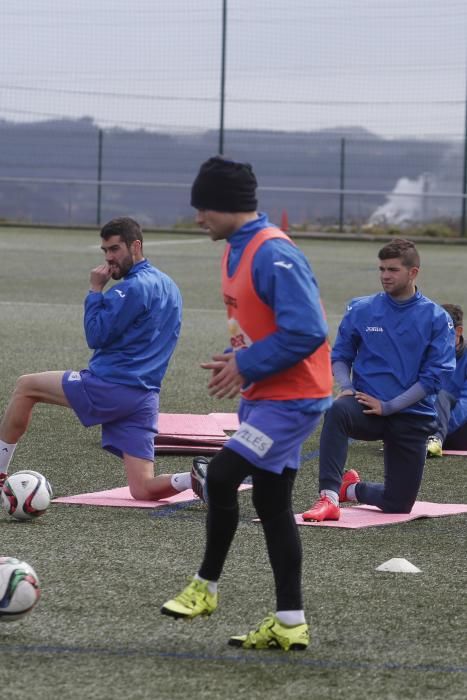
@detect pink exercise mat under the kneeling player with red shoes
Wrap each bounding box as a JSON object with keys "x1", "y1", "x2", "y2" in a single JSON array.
[{"x1": 295, "y1": 501, "x2": 467, "y2": 529}]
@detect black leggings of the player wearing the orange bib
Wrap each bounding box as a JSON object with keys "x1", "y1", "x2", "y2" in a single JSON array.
[{"x1": 199, "y1": 447, "x2": 303, "y2": 610}]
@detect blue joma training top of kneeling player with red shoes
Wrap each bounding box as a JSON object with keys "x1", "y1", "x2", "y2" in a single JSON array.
[{"x1": 331, "y1": 291, "x2": 455, "y2": 415}]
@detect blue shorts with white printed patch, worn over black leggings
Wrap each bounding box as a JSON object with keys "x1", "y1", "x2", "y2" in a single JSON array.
[{"x1": 225, "y1": 399, "x2": 322, "y2": 474}]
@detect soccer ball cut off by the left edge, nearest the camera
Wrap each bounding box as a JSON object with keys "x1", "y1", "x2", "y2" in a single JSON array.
[{"x1": 0, "y1": 557, "x2": 41, "y2": 622}]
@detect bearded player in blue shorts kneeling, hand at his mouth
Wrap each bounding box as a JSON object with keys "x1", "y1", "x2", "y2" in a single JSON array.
[{"x1": 0, "y1": 218, "x2": 199, "y2": 500}]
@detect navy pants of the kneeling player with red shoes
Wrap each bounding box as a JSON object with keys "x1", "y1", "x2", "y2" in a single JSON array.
[{"x1": 319, "y1": 396, "x2": 436, "y2": 513}]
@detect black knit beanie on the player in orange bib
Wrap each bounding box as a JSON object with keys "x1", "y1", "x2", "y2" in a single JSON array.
[{"x1": 191, "y1": 156, "x2": 258, "y2": 212}]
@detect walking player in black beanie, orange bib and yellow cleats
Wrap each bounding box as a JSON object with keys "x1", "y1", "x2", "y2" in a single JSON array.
[{"x1": 161, "y1": 157, "x2": 332, "y2": 650}]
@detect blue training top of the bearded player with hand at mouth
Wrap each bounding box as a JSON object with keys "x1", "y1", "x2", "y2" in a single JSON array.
[{"x1": 84, "y1": 260, "x2": 182, "y2": 392}]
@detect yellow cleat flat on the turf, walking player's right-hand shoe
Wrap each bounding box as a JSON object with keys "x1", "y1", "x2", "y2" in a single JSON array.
[{"x1": 229, "y1": 613, "x2": 310, "y2": 651}]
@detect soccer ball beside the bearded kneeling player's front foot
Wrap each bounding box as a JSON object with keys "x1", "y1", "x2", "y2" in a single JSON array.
[{"x1": 1, "y1": 470, "x2": 52, "y2": 520}]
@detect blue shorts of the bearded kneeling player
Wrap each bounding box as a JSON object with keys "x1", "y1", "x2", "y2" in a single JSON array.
[{"x1": 62, "y1": 369, "x2": 159, "y2": 461}]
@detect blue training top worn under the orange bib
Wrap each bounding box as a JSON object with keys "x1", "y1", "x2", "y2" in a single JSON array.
[{"x1": 227, "y1": 214, "x2": 331, "y2": 412}]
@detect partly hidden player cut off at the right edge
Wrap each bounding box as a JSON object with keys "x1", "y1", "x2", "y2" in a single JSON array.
[{"x1": 426, "y1": 304, "x2": 467, "y2": 457}]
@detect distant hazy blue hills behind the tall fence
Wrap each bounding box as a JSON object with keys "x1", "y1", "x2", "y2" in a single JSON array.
[{"x1": 0, "y1": 118, "x2": 463, "y2": 225}]
